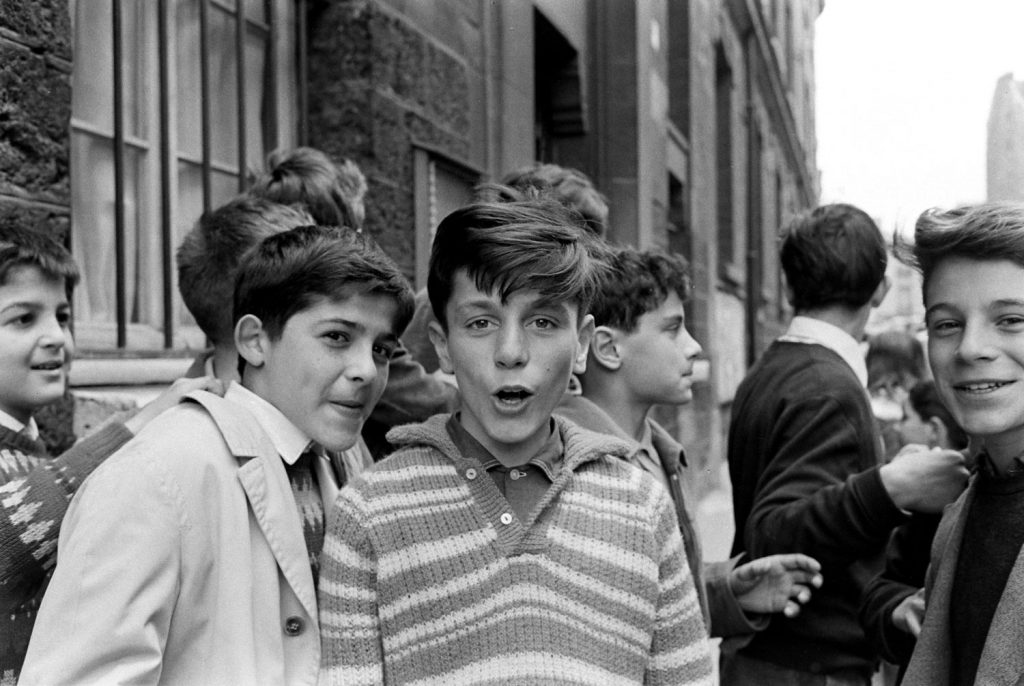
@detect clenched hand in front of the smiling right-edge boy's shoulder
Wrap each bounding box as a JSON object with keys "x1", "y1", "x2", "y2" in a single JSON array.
[{"x1": 881, "y1": 444, "x2": 968, "y2": 512}]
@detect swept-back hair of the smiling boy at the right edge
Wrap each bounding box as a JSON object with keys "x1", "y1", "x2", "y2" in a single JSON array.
[{"x1": 896, "y1": 202, "x2": 1024, "y2": 292}]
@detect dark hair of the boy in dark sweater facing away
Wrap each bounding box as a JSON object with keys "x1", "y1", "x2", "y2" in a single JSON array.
[{"x1": 779, "y1": 204, "x2": 888, "y2": 313}]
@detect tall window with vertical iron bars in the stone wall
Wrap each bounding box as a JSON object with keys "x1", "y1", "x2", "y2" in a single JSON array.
[{"x1": 71, "y1": 0, "x2": 296, "y2": 351}]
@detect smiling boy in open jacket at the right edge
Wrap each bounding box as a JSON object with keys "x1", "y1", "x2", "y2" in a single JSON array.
[{"x1": 903, "y1": 203, "x2": 1024, "y2": 686}]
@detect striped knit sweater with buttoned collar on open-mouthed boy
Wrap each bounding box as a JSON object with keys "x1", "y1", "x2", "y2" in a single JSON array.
[{"x1": 319, "y1": 415, "x2": 712, "y2": 686}]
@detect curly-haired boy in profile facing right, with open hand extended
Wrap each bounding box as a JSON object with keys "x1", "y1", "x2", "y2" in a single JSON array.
[{"x1": 555, "y1": 248, "x2": 821, "y2": 636}]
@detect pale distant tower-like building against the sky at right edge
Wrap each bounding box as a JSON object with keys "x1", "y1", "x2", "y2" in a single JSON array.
[{"x1": 988, "y1": 74, "x2": 1024, "y2": 201}]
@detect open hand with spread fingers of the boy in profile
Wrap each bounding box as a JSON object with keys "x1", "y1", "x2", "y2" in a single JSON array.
[{"x1": 729, "y1": 553, "x2": 822, "y2": 617}]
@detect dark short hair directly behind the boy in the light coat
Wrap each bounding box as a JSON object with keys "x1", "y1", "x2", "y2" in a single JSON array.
[{"x1": 177, "y1": 196, "x2": 312, "y2": 344}]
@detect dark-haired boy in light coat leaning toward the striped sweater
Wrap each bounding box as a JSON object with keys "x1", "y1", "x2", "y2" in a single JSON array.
[{"x1": 23, "y1": 226, "x2": 413, "y2": 684}]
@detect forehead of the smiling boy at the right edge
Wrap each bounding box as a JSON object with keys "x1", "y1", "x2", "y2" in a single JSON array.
[{"x1": 925, "y1": 257, "x2": 1024, "y2": 307}]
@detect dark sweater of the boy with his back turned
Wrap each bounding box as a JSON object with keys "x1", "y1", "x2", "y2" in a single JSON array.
[{"x1": 728, "y1": 341, "x2": 905, "y2": 676}]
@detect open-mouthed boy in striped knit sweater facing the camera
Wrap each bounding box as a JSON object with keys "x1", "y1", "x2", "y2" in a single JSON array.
[{"x1": 321, "y1": 201, "x2": 712, "y2": 684}]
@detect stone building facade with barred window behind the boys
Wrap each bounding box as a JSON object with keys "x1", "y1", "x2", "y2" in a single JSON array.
[{"x1": 0, "y1": 0, "x2": 823, "y2": 497}]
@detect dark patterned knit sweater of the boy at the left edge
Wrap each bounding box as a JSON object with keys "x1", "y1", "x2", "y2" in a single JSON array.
[{"x1": 0, "y1": 423, "x2": 132, "y2": 684}]
